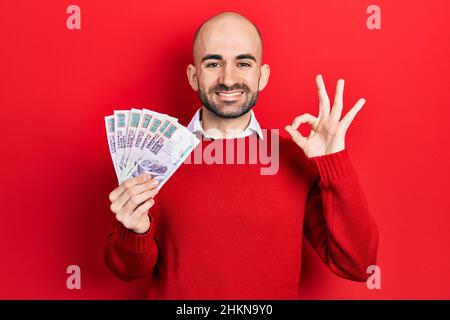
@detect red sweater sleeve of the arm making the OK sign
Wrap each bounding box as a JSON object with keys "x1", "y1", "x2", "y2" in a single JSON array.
[{"x1": 304, "y1": 149, "x2": 378, "y2": 281}]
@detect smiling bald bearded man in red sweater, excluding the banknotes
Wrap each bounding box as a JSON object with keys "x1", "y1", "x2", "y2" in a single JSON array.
[{"x1": 105, "y1": 12, "x2": 378, "y2": 299}]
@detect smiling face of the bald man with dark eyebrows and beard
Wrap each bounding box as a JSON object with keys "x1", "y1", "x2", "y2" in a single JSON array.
[{"x1": 188, "y1": 15, "x2": 265, "y2": 118}]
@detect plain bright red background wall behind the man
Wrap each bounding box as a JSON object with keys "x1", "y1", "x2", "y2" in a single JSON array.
[{"x1": 0, "y1": 0, "x2": 450, "y2": 299}]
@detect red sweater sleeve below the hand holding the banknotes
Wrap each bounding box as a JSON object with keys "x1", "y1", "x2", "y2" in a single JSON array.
[{"x1": 104, "y1": 205, "x2": 158, "y2": 282}]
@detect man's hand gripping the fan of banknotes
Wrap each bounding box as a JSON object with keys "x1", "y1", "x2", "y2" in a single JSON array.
[{"x1": 109, "y1": 174, "x2": 158, "y2": 234}]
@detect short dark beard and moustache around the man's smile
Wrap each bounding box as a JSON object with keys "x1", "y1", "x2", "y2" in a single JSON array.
[{"x1": 198, "y1": 81, "x2": 259, "y2": 119}]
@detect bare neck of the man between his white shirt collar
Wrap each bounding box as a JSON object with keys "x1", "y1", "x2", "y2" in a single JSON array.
[{"x1": 201, "y1": 107, "x2": 251, "y2": 138}]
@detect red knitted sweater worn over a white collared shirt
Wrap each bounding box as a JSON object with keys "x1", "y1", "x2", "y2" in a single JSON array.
[{"x1": 105, "y1": 130, "x2": 378, "y2": 299}]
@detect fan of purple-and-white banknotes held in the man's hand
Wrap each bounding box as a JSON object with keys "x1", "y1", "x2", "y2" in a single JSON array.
[{"x1": 105, "y1": 109, "x2": 200, "y2": 189}]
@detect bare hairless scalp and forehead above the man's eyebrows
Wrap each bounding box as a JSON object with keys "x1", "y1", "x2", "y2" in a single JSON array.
[{"x1": 193, "y1": 12, "x2": 262, "y2": 63}]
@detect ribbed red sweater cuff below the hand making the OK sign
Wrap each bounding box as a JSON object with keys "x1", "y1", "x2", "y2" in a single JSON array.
[{"x1": 309, "y1": 149, "x2": 354, "y2": 183}]
